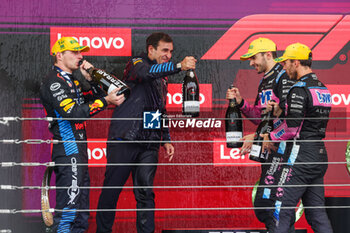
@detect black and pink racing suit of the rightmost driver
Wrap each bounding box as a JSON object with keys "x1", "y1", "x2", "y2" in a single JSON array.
[{"x1": 269, "y1": 73, "x2": 333, "y2": 233}]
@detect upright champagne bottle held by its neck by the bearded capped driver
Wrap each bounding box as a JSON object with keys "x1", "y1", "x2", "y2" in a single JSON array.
[{"x1": 225, "y1": 85, "x2": 243, "y2": 148}]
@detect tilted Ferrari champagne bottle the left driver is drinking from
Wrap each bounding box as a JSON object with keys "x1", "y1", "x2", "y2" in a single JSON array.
[{"x1": 86, "y1": 67, "x2": 130, "y2": 98}]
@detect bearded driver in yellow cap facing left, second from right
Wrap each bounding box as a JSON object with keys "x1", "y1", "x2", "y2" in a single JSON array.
[{"x1": 226, "y1": 38, "x2": 294, "y2": 232}]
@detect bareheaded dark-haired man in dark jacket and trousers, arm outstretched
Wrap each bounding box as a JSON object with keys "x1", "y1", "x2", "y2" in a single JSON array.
[{"x1": 96, "y1": 32, "x2": 197, "y2": 233}]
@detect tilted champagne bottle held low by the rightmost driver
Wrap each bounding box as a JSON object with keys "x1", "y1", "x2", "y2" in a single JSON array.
[{"x1": 249, "y1": 106, "x2": 273, "y2": 163}]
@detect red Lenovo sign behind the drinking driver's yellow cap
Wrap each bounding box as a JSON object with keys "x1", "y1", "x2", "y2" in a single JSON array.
[{"x1": 50, "y1": 27, "x2": 131, "y2": 56}]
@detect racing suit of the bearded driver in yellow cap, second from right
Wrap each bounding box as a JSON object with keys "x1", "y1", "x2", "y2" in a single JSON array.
[{"x1": 239, "y1": 64, "x2": 295, "y2": 228}]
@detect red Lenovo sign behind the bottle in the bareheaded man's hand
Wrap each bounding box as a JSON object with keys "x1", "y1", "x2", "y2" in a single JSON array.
[{"x1": 166, "y1": 84, "x2": 213, "y2": 111}]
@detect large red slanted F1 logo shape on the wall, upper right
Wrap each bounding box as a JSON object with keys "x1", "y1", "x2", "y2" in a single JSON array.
[{"x1": 201, "y1": 14, "x2": 350, "y2": 61}]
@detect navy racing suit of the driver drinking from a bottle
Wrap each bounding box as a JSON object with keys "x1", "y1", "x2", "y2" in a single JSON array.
[{"x1": 40, "y1": 66, "x2": 107, "y2": 232}]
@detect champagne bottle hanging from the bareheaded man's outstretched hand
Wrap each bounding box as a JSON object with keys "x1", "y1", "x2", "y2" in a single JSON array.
[{"x1": 182, "y1": 70, "x2": 199, "y2": 117}]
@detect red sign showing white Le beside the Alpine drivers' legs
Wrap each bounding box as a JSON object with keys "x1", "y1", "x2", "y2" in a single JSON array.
[{"x1": 213, "y1": 138, "x2": 259, "y2": 166}]
